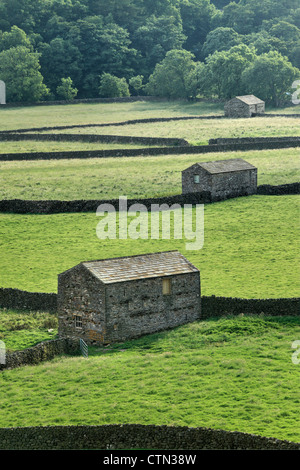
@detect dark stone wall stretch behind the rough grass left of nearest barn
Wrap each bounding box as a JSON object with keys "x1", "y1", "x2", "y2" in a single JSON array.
[{"x1": 0, "y1": 287, "x2": 57, "y2": 312}]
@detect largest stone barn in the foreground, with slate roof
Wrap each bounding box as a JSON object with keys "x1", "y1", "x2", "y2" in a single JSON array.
[{"x1": 58, "y1": 251, "x2": 201, "y2": 345}]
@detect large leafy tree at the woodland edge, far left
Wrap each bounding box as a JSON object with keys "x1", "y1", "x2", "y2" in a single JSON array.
[{"x1": 0, "y1": 46, "x2": 49, "y2": 101}]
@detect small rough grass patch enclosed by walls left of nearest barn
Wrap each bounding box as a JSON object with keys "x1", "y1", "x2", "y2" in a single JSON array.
[{"x1": 0, "y1": 309, "x2": 57, "y2": 351}]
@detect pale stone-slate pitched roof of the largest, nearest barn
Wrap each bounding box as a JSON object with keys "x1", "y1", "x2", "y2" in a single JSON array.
[{"x1": 80, "y1": 251, "x2": 198, "y2": 284}]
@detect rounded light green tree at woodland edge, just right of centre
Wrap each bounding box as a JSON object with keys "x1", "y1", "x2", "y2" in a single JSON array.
[{"x1": 146, "y1": 49, "x2": 200, "y2": 99}]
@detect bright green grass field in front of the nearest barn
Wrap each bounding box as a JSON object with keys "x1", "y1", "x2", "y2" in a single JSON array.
[{"x1": 0, "y1": 316, "x2": 300, "y2": 442}]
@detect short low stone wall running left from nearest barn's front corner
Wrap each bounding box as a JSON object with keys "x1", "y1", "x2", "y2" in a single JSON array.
[{"x1": 0, "y1": 338, "x2": 80, "y2": 370}]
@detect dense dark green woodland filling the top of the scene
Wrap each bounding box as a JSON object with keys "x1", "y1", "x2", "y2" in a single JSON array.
[{"x1": 0, "y1": 0, "x2": 300, "y2": 106}]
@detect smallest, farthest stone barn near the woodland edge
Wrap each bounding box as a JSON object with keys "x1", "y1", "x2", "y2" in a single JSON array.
[{"x1": 224, "y1": 95, "x2": 265, "y2": 118}]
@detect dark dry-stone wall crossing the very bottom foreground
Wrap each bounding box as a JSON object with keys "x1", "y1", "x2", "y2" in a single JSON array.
[{"x1": 0, "y1": 424, "x2": 300, "y2": 450}]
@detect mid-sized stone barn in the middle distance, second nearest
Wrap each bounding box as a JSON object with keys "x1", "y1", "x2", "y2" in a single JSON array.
[{"x1": 182, "y1": 158, "x2": 257, "y2": 201}]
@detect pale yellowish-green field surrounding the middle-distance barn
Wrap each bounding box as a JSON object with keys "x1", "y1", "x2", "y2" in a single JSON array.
[{"x1": 0, "y1": 148, "x2": 299, "y2": 200}]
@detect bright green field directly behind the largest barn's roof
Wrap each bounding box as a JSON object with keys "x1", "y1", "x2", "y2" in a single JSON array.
[{"x1": 0, "y1": 195, "x2": 300, "y2": 298}]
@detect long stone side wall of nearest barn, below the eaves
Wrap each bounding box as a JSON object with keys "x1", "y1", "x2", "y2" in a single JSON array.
[{"x1": 106, "y1": 273, "x2": 201, "y2": 342}]
